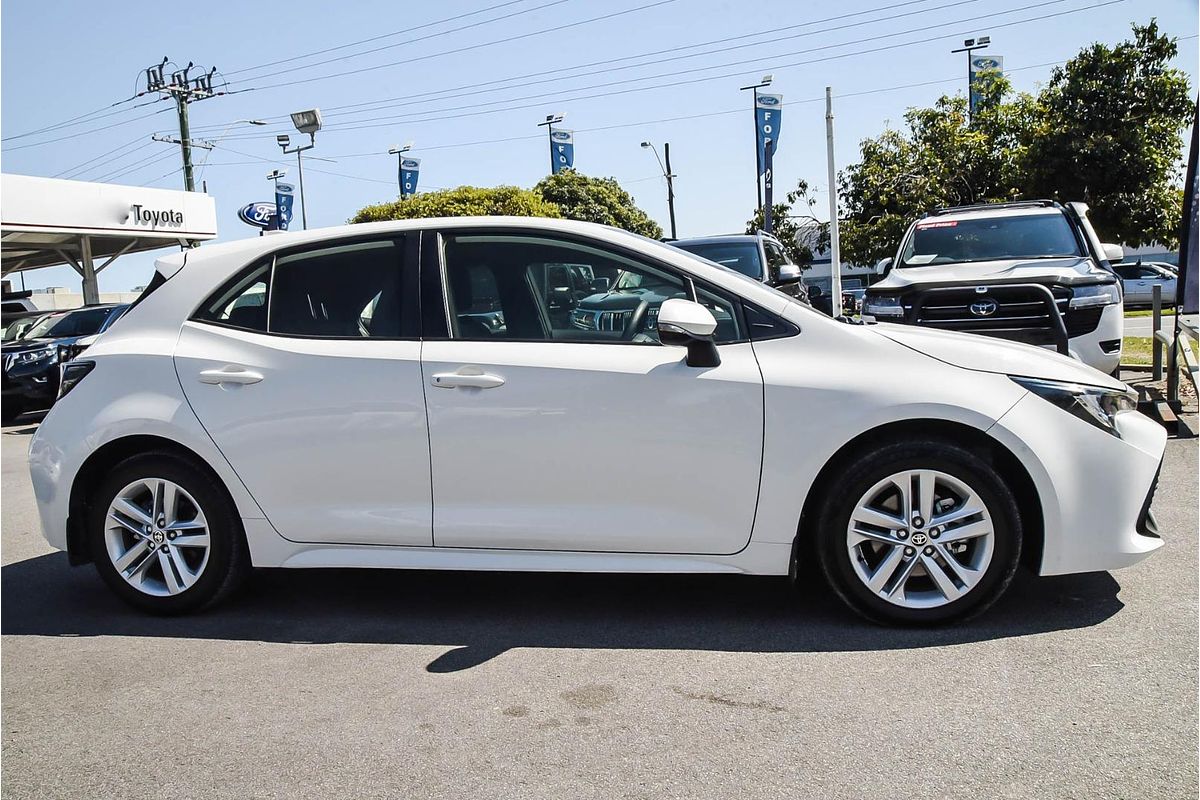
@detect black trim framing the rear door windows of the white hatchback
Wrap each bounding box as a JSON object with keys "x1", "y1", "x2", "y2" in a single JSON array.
[{"x1": 187, "y1": 229, "x2": 421, "y2": 342}]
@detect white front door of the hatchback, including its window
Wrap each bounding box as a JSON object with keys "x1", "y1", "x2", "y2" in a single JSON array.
[{"x1": 422, "y1": 233, "x2": 763, "y2": 554}]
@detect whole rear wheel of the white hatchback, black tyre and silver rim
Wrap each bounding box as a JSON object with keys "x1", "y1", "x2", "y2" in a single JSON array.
[{"x1": 88, "y1": 452, "x2": 250, "y2": 614}]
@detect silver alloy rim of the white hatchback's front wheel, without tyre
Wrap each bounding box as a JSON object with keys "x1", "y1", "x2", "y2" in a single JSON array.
[{"x1": 846, "y1": 469, "x2": 996, "y2": 608}]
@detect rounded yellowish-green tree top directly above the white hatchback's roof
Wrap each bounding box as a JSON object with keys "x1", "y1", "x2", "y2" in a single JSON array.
[{"x1": 350, "y1": 186, "x2": 563, "y2": 223}]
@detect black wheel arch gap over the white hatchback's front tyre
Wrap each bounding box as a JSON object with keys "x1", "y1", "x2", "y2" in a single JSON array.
[{"x1": 792, "y1": 419, "x2": 1045, "y2": 570}]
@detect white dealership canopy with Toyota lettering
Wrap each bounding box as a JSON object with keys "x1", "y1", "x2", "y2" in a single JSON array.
[{"x1": 0, "y1": 175, "x2": 217, "y2": 305}]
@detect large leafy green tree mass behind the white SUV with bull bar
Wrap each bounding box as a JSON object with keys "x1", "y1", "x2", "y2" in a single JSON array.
[{"x1": 839, "y1": 22, "x2": 1193, "y2": 264}]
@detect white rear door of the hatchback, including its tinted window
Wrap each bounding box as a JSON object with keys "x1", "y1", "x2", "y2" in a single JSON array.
[{"x1": 175, "y1": 232, "x2": 432, "y2": 546}]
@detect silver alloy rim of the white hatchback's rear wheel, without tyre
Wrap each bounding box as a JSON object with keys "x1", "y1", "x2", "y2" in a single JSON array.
[{"x1": 104, "y1": 477, "x2": 210, "y2": 597}]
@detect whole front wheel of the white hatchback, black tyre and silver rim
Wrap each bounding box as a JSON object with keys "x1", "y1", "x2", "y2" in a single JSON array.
[{"x1": 816, "y1": 440, "x2": 1021, "y2": 625}]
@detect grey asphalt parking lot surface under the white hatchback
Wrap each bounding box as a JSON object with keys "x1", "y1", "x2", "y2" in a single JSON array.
[{"x1": 0, "y1": 410, "x2": 1198, "y2": 799}]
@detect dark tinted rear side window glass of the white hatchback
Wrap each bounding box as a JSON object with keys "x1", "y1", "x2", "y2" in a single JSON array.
[{"x1": 196, "y1": 240, "x2": 402, "y2": 338}]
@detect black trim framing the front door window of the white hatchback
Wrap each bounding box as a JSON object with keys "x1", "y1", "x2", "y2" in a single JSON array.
[{"x1": 432, "y1": 225, "x2": 751, "y2": 348}]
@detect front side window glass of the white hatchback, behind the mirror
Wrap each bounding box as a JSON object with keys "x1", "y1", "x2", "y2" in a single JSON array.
[{"x1": 444, "y1": 234, "x2": 742, "y2": 344}]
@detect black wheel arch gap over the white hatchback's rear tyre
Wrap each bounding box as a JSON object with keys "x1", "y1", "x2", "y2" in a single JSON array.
[{"x1": 67, "y1": 434, "x2": 238, "y2": 566}]
